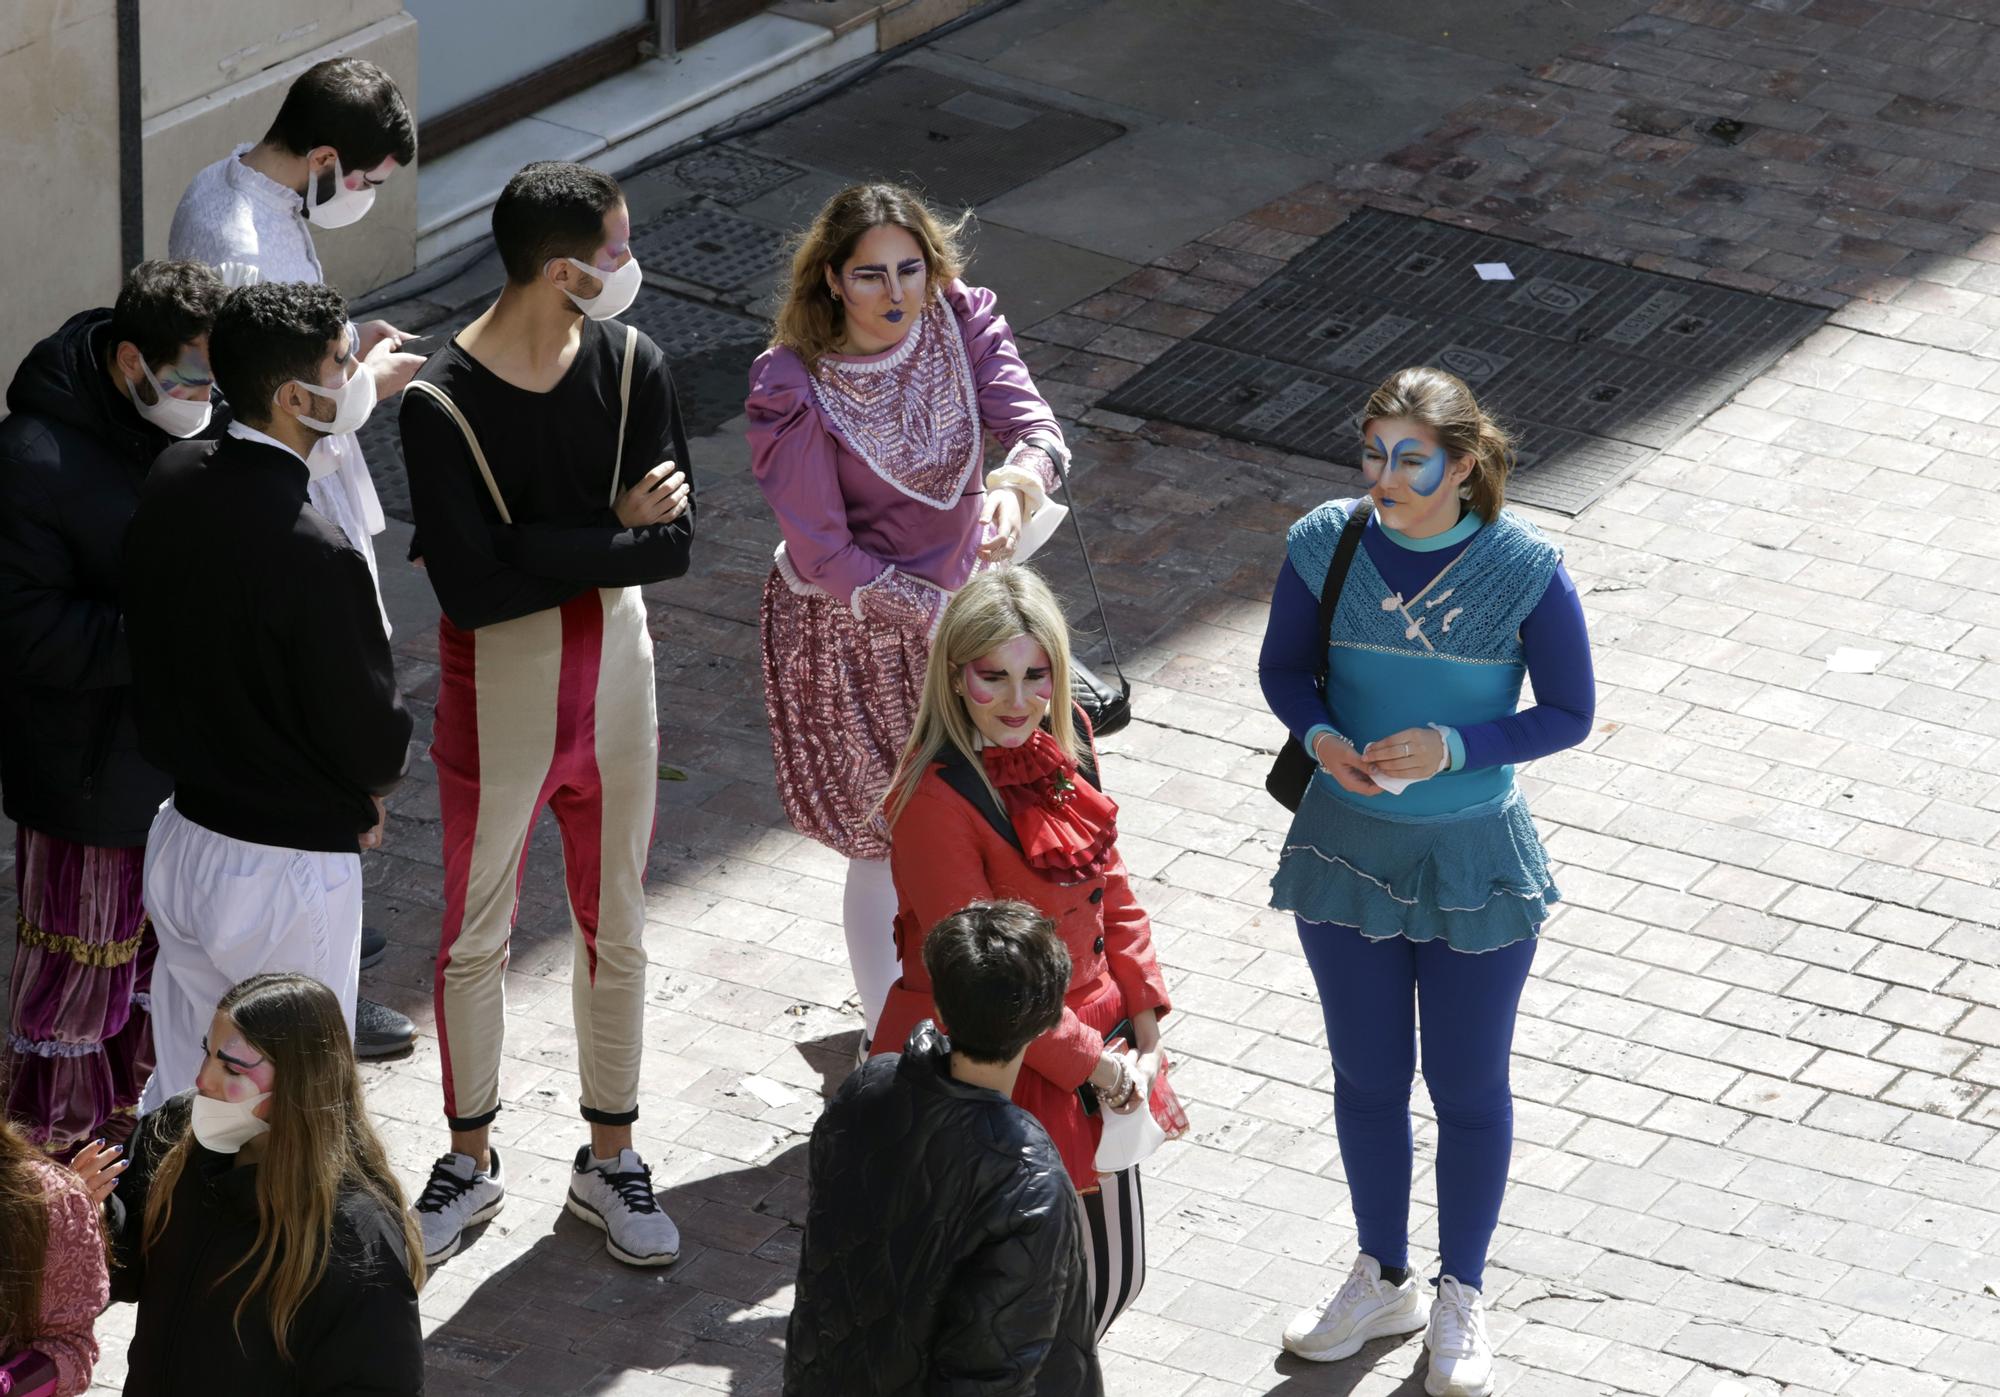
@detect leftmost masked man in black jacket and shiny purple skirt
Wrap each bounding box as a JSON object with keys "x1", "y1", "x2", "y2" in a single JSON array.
[{"x1": 0, "y1": 262, "x2": 226, "y2": 1153}]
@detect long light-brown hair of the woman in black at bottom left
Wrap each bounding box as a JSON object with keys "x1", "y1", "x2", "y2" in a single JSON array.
[{"x1": 144, "y1": 975, "x2": 424, "y2": 1361}]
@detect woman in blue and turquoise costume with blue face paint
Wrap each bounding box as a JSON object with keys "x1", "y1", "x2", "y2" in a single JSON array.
[{"x1": 1258, "y1": 368, "x2": 1594, "y2": 1397}]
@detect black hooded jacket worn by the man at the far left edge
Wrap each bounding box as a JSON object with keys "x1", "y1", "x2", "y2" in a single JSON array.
[{"x1": 0, "y1": 310, "x2": 174, "y2": 849}]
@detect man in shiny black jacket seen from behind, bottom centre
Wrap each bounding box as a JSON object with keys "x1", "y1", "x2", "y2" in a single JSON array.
[{"x1": 784, "y1": 903, "x2": 1104, "y2": 1397}]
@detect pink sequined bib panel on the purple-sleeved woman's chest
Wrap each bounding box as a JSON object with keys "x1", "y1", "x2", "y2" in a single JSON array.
[{"x1": 812, "y1": 298, "x2": 982, "y2": 510}]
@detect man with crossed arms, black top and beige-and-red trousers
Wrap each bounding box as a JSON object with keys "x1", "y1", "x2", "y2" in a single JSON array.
[{"x1": 402, "y1": 162, "x2": 694, "y2": 1265}]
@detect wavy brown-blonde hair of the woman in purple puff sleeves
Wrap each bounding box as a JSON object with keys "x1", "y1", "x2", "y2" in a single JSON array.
[{"x1": 770, "y1": 184, "x2": 972, "y2": 370}]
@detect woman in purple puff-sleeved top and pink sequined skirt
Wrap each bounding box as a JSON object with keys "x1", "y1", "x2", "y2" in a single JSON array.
[{"x1": 744, "y1": 184, "x2": 1070, "y2": 1035}]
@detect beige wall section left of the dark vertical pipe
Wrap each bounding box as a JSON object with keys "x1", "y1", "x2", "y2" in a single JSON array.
[{"x1": 0, "y1": 0, "x2": 124, "y2": 388}]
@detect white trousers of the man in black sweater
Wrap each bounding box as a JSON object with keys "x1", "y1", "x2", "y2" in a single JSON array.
[{"x1": 138, "y1": 801, "x2": 362, "y2": 1115}]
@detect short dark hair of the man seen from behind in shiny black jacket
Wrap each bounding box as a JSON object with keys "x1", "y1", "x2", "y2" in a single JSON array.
[{"x1": 924, "y1": 903, "x2": 1070, "y2": 1063}]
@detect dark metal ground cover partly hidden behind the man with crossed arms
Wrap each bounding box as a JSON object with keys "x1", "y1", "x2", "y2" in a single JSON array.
[{"x1": 360, "y1": 288, "x2": 770, "y2": 520}]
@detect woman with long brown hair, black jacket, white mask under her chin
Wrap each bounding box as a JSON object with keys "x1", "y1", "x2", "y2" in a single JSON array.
[{"x1": 112, "y1": 975, "x2": 424, "y2": 1397}]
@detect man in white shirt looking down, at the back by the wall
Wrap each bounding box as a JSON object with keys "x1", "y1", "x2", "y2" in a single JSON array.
[{"x1": 166, "y1": 58, "x2": 424, "y2": 1057}]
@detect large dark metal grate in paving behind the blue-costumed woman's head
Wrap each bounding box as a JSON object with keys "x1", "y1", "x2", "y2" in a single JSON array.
[{"x1": 1104, "y1": 208, "x2": 1826, "y2": 514}]
